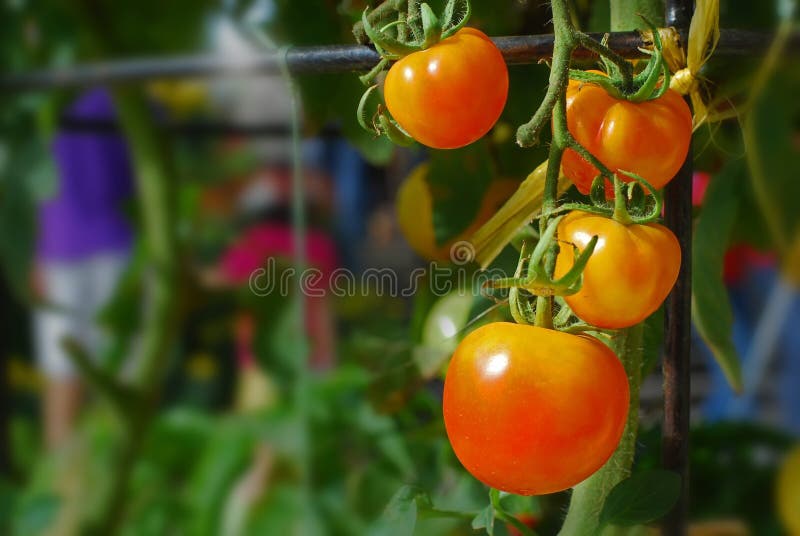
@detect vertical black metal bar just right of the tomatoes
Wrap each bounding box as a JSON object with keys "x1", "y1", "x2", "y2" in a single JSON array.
[{"x1": 662, "y1": 0, "x2": 694, "y2": 536}]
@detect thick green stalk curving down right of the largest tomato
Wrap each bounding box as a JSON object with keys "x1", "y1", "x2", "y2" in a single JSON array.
[{"x1": 559, "y1": 324, "x2": 644, "y2": 536}]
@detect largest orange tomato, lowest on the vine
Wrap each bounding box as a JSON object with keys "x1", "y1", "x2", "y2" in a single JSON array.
[{"x1": 444, "y1": 322, "x2": 629, "y2": 495}]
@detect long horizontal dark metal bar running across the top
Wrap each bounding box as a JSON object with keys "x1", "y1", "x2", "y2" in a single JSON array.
[{"x1": 0, "y1": 29, "x2": 800, "y2": 92}]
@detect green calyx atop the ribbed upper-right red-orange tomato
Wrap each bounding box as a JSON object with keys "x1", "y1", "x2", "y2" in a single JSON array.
[{"x1": 569, "y1": 17, "x2": 670, "y2": 102}]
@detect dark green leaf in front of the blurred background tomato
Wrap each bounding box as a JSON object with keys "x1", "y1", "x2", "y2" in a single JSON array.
[{"x1": 427, "y1": 139, "x2": 492, "y2": 245}]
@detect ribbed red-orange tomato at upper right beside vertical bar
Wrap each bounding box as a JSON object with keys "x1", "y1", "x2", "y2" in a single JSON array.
[{"x1": 561, "y1": 74, "x2": 692, "y2": 194}]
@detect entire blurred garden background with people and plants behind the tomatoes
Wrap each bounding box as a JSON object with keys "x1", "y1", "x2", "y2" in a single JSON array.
[{"x1": 0, "y1": 0, "x2": 800, "y2": 536}]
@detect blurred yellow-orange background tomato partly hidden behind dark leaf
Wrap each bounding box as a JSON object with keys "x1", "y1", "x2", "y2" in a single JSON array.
[{"x1": 395, "y1": 163, "x2": 520, "y2": 262}]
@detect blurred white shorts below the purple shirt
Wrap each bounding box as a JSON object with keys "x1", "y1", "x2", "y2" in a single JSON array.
[{"x1": 34, "y1": 252, "x2": 129, "y2": 380}]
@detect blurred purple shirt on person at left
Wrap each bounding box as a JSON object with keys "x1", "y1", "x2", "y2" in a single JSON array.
[{"x1": 37, "y1": 89, "x2": 133, "y2": 261}]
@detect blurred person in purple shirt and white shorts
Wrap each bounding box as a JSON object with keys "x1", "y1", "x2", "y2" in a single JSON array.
[{"x1": 33, "y1": 88, "x2": 133, "y2": 448}]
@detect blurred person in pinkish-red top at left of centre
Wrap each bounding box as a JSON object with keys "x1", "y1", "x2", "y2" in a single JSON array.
[{"x1": 201, "y1": 165, "x2": 338, "y2": 375}]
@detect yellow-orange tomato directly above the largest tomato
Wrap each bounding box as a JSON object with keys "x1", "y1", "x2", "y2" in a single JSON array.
[{"x1": 555, "y1": 211, "x2": 681, "y2": 328}]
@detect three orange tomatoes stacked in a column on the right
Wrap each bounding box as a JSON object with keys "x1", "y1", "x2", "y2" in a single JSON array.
[{"x1": 443, "y1": 72, "x2": 692, "y2": 495}]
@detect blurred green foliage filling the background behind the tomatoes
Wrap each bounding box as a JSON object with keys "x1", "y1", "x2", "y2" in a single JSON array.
[{"x1": 0, "y1": 0, "x2": 800, "y2": 536}]
